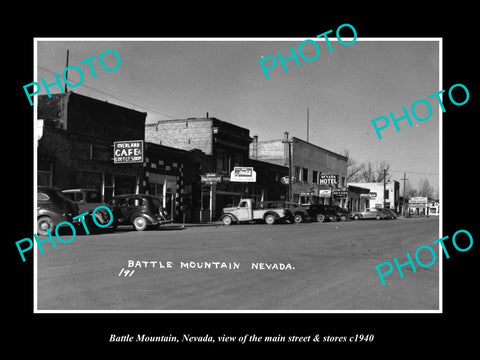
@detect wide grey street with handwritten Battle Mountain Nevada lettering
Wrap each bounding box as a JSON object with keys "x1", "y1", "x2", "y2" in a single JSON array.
[{"x1": 37, "y1": 218, "x2": 441, "y2": 310}]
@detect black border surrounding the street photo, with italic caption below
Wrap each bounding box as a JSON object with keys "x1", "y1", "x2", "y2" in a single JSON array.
[{"x1": 7, "y1": 7, "x2": 478, "y2": 356}]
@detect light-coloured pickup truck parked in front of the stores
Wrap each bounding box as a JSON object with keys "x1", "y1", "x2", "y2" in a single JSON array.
[{"x1": 221, "y1": 199, "x2": 292, "y2": 225}]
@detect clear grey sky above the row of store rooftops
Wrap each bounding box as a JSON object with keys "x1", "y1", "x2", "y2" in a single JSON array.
[{"x1": 35, "y1": 36, "x2": 440, "y2": 191}]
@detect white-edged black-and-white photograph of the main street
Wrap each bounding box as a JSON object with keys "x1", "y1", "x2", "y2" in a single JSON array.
[{"x1": 31, "y1": 37, "x2": 442, "y2": 313}]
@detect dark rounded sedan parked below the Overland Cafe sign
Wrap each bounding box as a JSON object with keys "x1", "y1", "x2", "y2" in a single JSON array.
[{"x1": 111, "y1": 194, "x2": 172, "y2": 231}]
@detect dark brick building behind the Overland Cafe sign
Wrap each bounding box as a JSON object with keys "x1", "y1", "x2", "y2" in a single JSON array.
[{"x1": 37, "y1": 92, "x2": 146, "y2": 200}]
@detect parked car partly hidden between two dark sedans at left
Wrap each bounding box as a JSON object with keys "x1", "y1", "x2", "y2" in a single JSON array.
[{"x1": 62, "y1": 189, "x2": 117, "y2": 229}]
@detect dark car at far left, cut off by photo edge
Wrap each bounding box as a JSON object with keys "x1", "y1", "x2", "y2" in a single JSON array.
[{"x1": 37, "y1": 186, "x2": 79, "y2": 235}]
